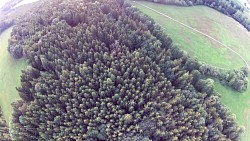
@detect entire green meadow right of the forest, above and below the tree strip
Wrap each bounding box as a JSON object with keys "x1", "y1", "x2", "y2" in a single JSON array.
[{"x1": 131, "y1": 1, "x2": 250, "y2": 141}]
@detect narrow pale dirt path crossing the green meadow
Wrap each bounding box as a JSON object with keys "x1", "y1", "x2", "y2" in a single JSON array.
[{"x1": 133, "y1": 1, "x2": 250, "y2": 71}]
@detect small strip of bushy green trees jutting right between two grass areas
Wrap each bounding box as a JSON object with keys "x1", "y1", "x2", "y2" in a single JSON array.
[{"x1": 199, "y1": 64, "x2": 248, "y2": 92}]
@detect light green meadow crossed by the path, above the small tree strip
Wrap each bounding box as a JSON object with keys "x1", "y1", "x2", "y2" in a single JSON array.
[{"x1": 133, "y1": 2, "x2": 250, "y2": 69}]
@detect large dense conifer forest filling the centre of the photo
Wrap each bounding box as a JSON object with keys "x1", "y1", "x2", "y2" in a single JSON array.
[{"x1": 5, "y1": 0, "x2": 243, "y2": 141}]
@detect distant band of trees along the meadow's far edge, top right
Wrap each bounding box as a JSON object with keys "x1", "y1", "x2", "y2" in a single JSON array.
[{"x1": 139, "y1": 0, "x2": 250, "y2": 31}]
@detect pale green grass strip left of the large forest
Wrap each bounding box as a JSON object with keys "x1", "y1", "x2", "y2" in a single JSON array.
[{"x1": 0, "y1": 28, "x2": 27, "y2": 121}]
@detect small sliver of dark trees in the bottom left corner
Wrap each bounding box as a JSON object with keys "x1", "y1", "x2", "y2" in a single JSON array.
[{"x1": 0, "y1": 107, "x2": 11, "y2": 141}]
